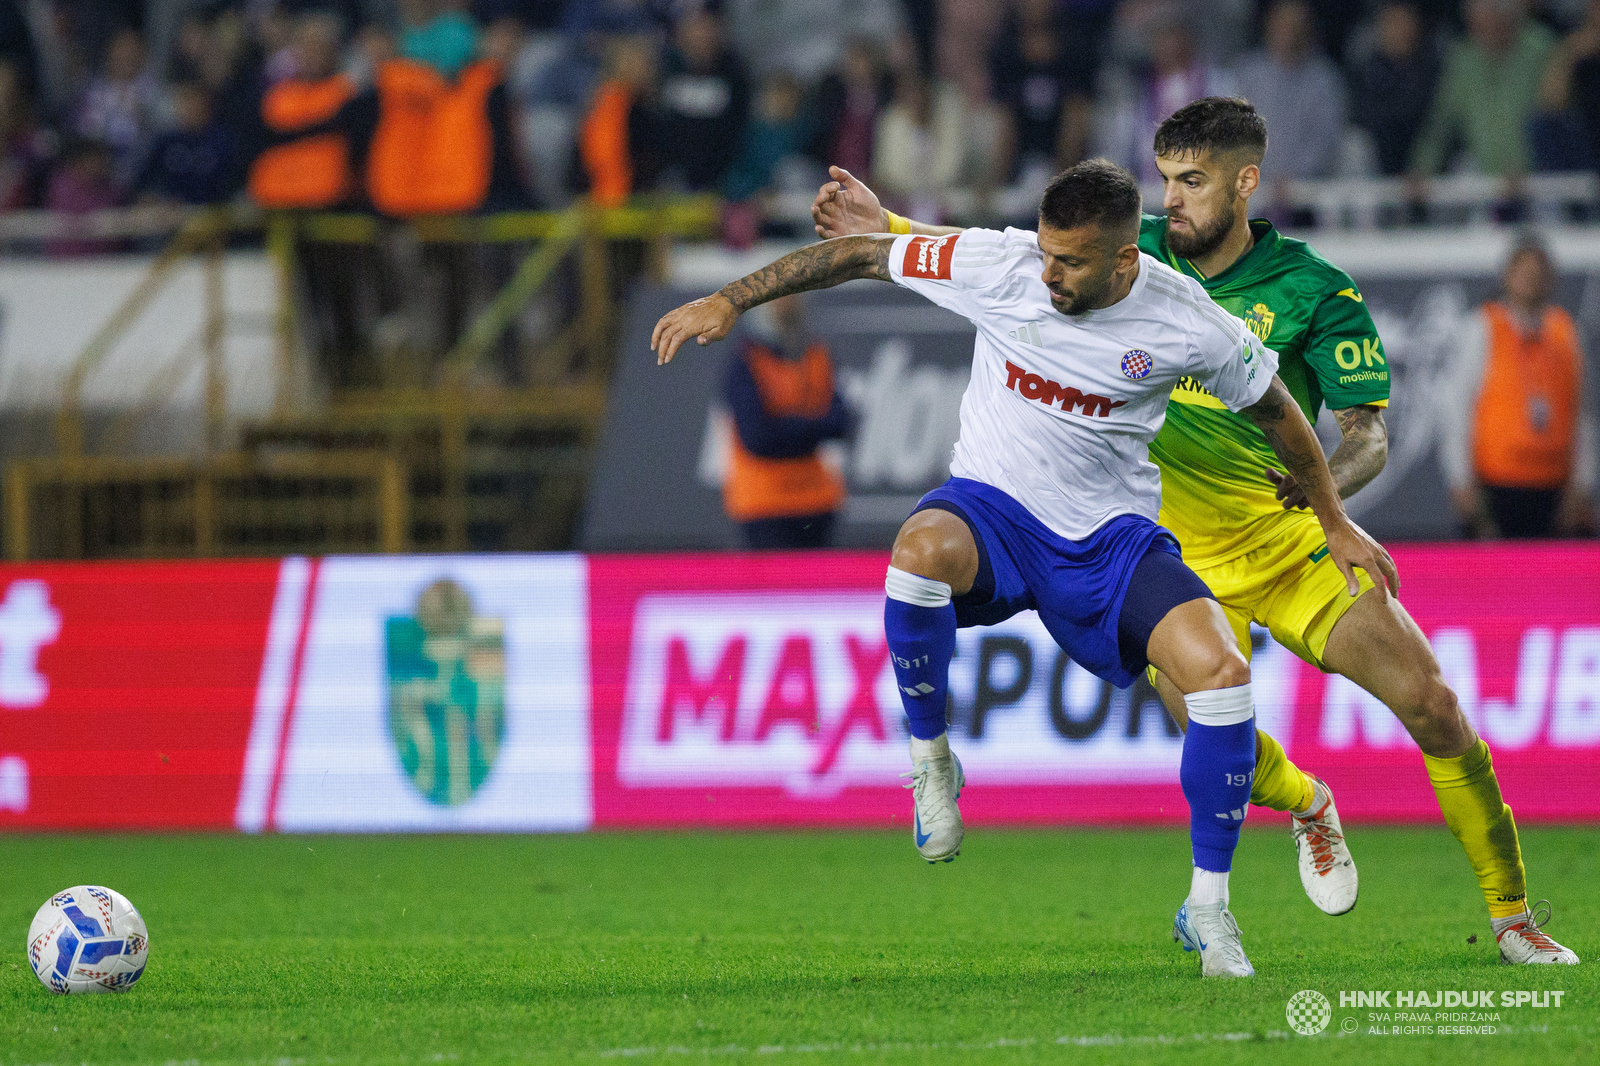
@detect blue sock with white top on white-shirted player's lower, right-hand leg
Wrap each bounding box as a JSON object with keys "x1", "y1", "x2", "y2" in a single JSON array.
[{"x1": 1178, "y1": 683, "x2": 1256, "y2": 872}]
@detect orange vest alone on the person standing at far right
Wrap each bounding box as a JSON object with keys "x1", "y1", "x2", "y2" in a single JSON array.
[{"x1": 1472, "y1": 303, "x2": 1582, "y2": 488}]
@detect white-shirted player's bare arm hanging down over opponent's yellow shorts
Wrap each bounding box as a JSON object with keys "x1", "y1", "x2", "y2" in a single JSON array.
[{"x1": 1242, "y1": 375, "x2": 1400, "y2": 599}]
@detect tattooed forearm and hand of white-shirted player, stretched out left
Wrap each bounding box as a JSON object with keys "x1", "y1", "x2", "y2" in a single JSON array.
[{"x1": 650, "y1": 235, "x2": 894, "y2": 365}]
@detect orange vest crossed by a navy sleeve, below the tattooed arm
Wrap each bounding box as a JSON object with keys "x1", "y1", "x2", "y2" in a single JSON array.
[{"x1": 722, "y1": 344, "x2": 845, "y2": 522}]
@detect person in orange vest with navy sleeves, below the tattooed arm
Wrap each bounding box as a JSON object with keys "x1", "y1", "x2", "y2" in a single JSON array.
[{"x1": 723, "y1": 295, "x2": 854, "y2": 549}]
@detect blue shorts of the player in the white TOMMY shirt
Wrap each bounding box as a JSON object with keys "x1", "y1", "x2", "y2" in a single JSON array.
[{"x1": 917, "y1": 477, "x2": 1211, "y2": 688}]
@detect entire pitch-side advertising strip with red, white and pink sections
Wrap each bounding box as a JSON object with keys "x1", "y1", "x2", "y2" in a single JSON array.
[{"x1": 0, "y1": 544, "x2": 1600, "y2": 832}]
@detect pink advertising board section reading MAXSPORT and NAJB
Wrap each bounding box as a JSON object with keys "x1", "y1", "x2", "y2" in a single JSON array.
[{"x1": 589, "y1": 544, "x2": 1600, "y2": 826}]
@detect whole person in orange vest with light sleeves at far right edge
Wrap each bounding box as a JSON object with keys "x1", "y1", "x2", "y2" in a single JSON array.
[{"x1": 1443, "y1": 237, "x2": 1595, "y2": 538}]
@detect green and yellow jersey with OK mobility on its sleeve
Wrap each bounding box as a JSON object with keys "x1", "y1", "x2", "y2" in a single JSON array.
[{"x1": 1139, "y1": 214, "x2": 1389, "y2": 565}]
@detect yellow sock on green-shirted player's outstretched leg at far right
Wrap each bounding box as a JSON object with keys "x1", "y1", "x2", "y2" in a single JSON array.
[{"x1": 1422, "y1": 739, "x2": 1528, "y2": 919}]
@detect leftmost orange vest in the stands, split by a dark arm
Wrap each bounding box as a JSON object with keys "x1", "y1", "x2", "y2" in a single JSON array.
[{"x1": 250, "y1": 74, "x2": 355, "y2": 208}]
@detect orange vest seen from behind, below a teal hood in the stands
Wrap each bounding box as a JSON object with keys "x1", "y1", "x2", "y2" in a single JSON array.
[{"x1": 366, "y1": 59, "x2": 501, "y2": 216}]
